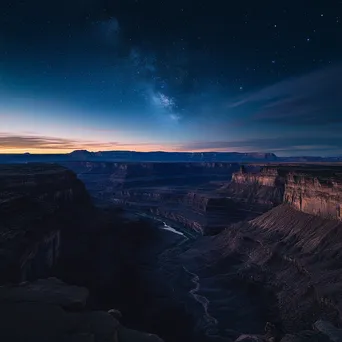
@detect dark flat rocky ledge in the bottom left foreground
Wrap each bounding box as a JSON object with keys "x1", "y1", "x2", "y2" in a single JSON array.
[{"x1": 0, "y1": 278, "x2": 162, "y2": 342}]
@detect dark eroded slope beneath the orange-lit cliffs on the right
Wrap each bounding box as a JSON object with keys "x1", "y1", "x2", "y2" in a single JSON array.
[{"x1": 167, "y1": 204, "x2": 342, "y2": 342}]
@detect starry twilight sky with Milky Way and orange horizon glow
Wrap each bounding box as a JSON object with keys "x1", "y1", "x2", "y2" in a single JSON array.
[{"x1": 0, "y1": 0, "x2": 342, "y2": 156}]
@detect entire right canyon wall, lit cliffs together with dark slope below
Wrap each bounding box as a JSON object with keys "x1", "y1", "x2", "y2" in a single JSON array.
[{"x1": 163, "y1": 165, "x2": 342, "y2": 341}]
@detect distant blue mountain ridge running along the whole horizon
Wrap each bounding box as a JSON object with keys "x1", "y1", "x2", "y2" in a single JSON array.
[{"x1": 0, "y1": 150, "x2": 342, "y2": 163}]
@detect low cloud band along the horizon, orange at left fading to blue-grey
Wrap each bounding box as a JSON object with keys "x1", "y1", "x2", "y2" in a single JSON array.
[{"x1": 0, "y1": 133, "x2": 342, "y2": 156}]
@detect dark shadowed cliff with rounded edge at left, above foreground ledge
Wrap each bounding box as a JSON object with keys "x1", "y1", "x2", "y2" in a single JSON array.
[{"x1": 0, "y1": 164, "x2": 91, "y2": 282}]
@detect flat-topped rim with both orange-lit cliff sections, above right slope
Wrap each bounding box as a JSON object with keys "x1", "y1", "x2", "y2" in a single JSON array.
[{"x1": 227, "y1": 165, "x2": 342, "y2": 221}]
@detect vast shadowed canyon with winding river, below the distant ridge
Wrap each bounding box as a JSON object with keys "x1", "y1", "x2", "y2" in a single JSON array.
[{"x1": 0, "y1": 161, "x2": 342, "y2": 342}]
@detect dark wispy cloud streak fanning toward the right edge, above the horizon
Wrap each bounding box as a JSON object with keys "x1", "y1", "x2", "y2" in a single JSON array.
[{"x1": 229, "y1": 65, "x2": 342, "y2": 126}]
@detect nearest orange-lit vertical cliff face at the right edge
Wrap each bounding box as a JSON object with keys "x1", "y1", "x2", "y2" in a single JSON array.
[{"x1": 284, "y1": 173, "x2": 342, "y2": 221}]
